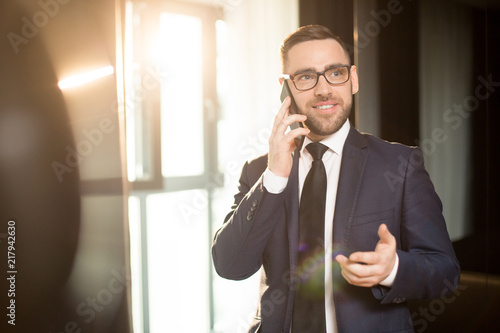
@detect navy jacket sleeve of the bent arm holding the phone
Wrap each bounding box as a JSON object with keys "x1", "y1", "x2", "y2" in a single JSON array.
[{"x1": 212, "y1": 159, "x2": 284, "y2": 280}]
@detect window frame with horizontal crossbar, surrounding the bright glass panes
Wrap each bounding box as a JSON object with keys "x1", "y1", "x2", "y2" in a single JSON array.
[{"x1": 122, "y1": 0, "x2": 224, "y2": 332}]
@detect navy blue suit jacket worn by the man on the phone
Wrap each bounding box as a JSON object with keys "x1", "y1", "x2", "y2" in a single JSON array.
[{"x1": 212, "y1": 127, "x2": 460, "y2": 333}]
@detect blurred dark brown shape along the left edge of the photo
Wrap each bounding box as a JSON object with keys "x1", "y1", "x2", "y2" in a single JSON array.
[{"x1": 0, "y1": 1, "x2": 80, "y2": 332}]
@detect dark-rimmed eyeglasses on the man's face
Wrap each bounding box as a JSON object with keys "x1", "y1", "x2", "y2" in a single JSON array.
[{"x1": 281, "y1": 65, "x2": 351, "y2": 90}]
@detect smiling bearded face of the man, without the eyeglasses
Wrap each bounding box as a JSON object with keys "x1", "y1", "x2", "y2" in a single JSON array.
[{"x1": 285, "y1": 39, "x2": 358, "y2": 141}]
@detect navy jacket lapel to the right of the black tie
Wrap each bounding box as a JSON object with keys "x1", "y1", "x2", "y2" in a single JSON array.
[{"x1": 333, "y1": 127, "x2": 368, "y2": 252}]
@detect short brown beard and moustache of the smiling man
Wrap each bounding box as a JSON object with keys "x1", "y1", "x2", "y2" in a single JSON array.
[{"x1": 300, "y1": 94, "x2": 352, "y2": 136}]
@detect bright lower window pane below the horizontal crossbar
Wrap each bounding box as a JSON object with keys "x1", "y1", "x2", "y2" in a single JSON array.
[{"x1": 147, "y1": 190, "x2": 210, "y2": 333}]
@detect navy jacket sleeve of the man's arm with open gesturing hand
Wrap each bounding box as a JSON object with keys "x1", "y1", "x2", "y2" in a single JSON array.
[{"x1": 372, "y1": 148, "x2": 460, "y2": 303}]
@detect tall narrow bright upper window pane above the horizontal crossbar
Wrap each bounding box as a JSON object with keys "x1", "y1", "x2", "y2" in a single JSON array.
[{"x1": 156, "y1": 13, "x2": 204, "y2": 177}]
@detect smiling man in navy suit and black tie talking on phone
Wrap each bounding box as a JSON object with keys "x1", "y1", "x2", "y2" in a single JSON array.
[{"x1": 212, "y1": 26, "x2": 460, "y2": 333}]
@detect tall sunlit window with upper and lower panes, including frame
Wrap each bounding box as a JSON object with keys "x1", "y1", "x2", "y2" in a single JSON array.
[{"x1": 124, "y1": 1, "x2": 218, "y2": 332}]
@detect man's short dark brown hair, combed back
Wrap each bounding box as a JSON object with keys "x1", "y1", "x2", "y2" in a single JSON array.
[{"x1": 280, "y1": 25, "x2": 351, "y2": 72}]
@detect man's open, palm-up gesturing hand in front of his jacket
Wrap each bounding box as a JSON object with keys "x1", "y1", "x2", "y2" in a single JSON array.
[{"x1": 335, "y1": 224, "x2": 396, "y2": 287}]
